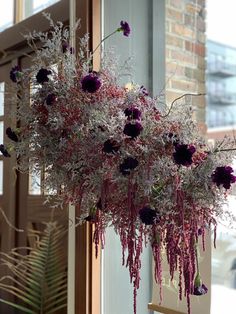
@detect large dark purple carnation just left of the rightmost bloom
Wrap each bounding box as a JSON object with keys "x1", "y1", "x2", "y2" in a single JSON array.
[{"x1": 173, "y1": 144, "x2": 196, "y2": 167}]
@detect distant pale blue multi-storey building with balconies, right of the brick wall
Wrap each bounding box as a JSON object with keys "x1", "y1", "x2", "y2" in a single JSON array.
[{"x1": 207, "y1": 40, "x2": 236, "y2": 131}]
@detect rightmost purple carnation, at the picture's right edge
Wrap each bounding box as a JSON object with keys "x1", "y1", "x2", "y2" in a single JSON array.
[{"x1": 211, "y1": 166, "x2": 236, "y2": 189}]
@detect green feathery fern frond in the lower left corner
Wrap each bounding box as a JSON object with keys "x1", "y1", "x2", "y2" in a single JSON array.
[{"x1": 0, "y1": 222, "x2": 67, "y2": 314}]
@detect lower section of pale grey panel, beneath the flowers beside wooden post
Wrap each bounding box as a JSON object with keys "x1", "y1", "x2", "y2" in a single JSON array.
[{"x1": 101, "y1": 228, "x2": 152, "y2": 314}]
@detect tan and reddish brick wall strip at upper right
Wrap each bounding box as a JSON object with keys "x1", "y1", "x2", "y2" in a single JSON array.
[{"x1": 166, "y1": 0, "x2": 206, "y2": 131}]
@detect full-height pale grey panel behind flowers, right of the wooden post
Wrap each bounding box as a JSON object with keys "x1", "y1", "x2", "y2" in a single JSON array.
[{"x1": 101, "y1": 0, "x2": 154, "y2": 314}]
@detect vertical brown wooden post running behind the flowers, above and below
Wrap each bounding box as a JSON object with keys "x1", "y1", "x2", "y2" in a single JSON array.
[{"x1": 75, "y1": 0, "x2": 101, "y2": 314}]
